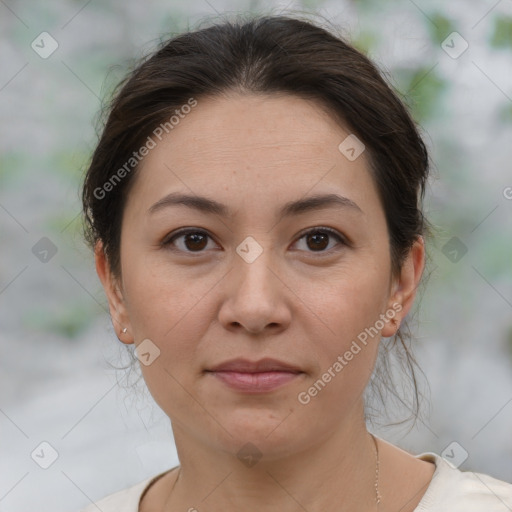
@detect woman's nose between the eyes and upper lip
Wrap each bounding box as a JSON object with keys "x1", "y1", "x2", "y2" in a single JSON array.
[{"x1": 218, "y1": 251, "x2": 293, "y2": 334}]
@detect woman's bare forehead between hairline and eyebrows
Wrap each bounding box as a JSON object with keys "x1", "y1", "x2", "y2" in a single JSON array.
[{"x1": 124, "y1": 94, "x2": 376, "y2": 218}]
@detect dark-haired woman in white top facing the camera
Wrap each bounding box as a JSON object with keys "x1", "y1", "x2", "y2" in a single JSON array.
[{"x1": 79, "y1": 16, "x2": 512, "y2": 512}]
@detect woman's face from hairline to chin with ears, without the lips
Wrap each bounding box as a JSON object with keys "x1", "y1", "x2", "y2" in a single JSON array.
[{"x1": 97, "y1": 95, "x2": 421, "y2": 458}]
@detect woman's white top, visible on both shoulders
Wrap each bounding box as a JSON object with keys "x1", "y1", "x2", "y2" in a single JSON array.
[{"x1": 80, "y1": 452, "x2": 512, "y2": 512}]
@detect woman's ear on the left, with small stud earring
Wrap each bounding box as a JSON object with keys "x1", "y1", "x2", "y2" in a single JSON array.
[{"x1": 94, "y1": 240, "x2": 133, "y2": 345}]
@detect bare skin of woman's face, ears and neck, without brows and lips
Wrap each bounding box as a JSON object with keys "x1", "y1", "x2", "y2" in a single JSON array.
[{"x1": 95, "y1": 93, "x2": 433, "y2": 512}]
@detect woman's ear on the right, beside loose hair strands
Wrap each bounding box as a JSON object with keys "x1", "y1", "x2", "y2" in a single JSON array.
[{"x1": 382, "y1": 236, "x2": 425, "y2": 338}]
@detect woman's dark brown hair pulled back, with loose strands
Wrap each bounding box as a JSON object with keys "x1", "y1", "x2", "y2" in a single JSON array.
[{"x1": 82, "y1": 15, "x2": 429, "y2": 428}]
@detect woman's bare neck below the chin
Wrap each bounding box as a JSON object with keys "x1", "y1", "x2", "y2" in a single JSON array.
[{"x1": 164, "y1": 404, "x2": 378, "y2": 512}]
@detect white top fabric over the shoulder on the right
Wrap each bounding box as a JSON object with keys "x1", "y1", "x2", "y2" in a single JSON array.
[{"x1": 415, "y1": 452, "x2": 512, "y2": 512}]
